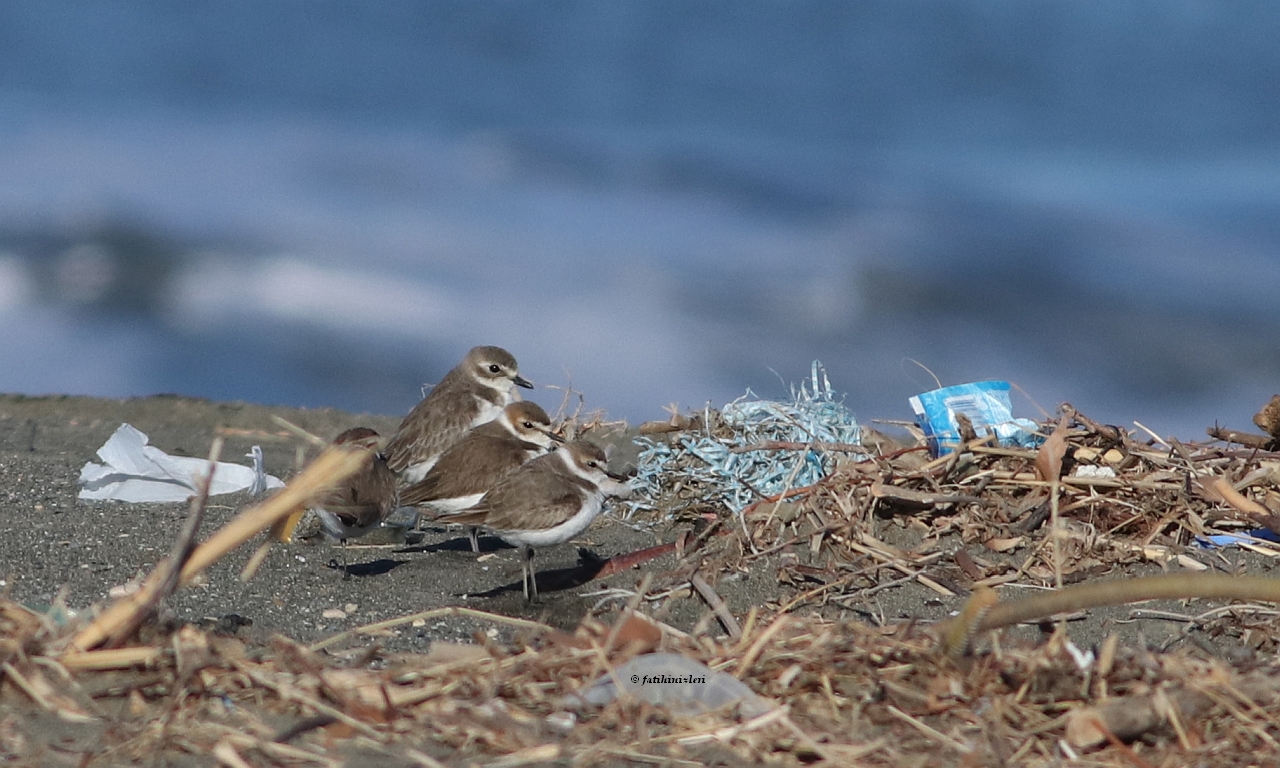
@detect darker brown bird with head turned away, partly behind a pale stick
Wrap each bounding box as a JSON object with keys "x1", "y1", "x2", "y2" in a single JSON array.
[{"x1": 311, "y1": 426, "x2": 398, "y2": 541}]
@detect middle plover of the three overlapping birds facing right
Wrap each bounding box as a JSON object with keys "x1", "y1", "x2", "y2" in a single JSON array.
[{"x1": 401, "y1": 401, "x2": 563, "y2": 552}]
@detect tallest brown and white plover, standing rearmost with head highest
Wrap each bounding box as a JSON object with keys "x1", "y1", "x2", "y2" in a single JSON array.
[{"x1": 384, "y1": 347, "x2": 534, "y2": 483}]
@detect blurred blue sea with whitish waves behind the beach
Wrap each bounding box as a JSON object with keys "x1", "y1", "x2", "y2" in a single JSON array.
[{"x1": 0, "y1": 0, "x2": 1280, "y2": 439}]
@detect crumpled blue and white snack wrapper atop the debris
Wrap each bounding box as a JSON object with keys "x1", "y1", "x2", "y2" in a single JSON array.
[{"x1": 910, "y1": 380, "x2": 1044, "y2": 457}]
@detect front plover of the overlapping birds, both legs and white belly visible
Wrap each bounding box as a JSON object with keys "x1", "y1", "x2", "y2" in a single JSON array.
[{"x1": 440, "y1": 440, "x2": 628, "y2": 599}]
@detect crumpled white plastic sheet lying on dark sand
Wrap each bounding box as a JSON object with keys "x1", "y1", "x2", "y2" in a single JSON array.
[{"x1": 79, "y1": 424, "x2": 284, "y2": 503}]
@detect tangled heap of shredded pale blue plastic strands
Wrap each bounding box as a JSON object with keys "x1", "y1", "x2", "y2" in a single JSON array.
[{"x1": 628, "y1": 361, "x2": 861, "y2": 516}]
